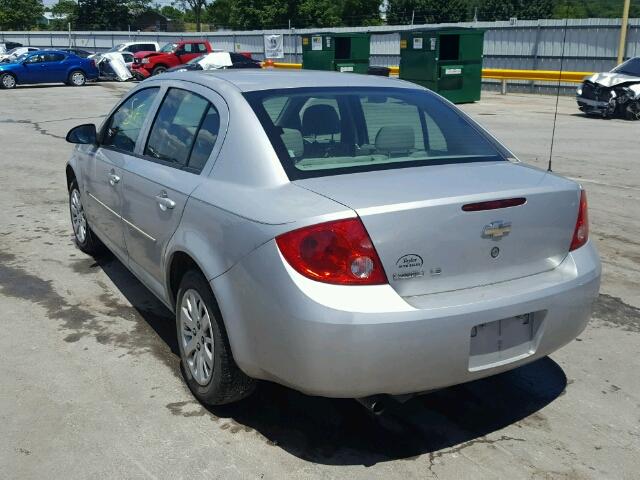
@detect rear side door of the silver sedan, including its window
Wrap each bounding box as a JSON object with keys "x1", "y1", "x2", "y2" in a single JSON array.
[{"x1": 122, "y1": 82, "x2": 228, "y2": 295}]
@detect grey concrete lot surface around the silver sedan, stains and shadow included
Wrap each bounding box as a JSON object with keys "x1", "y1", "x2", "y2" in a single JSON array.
[{"x1": 0, "y1": 83, "x2": 640, "y2": 480}]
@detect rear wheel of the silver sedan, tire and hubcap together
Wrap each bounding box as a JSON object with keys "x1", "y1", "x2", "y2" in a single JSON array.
[{"x1": 175, "y1": 270, "x2": 256, "y2": 405}]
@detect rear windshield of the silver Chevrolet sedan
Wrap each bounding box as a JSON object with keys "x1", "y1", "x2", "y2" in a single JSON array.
[{"x1": 245, "y1": 88, "x2": 506, "y2": 180}]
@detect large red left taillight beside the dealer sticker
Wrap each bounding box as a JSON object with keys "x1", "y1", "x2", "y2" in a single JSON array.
[{"x1": 276, "y1": 218, "x2": 387, "y2": 285}]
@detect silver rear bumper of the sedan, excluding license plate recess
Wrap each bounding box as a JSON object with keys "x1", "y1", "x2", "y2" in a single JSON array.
[{"x1": 211, "y1": 241, "x2": 600, "y2": 397}]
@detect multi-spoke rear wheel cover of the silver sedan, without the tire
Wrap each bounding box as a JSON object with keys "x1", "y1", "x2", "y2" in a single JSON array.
[{"x1": 179, "y1": 289, "x2": 214, "y2": 386}]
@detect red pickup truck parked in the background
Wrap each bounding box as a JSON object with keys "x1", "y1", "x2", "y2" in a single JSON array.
[{"x1": 131, "y1": 40, "x2": 212, "y2": 79}]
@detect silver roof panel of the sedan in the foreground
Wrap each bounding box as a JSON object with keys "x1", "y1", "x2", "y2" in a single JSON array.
[{"x1": 162, "y1": 69, "x2": 423, "y2": 92}]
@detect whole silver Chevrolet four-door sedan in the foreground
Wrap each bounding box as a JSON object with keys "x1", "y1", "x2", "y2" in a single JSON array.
[{"x1": 66, "y1": 70, "x2": 600, "y2": 404}]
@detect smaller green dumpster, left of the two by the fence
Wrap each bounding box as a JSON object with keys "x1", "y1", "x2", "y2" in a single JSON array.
[{"x1": 302, "y1": 32, "x2": 370, "y2": 73}]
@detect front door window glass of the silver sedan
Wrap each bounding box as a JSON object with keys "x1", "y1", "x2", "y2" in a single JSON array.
[{"x1": 102, "y1": 87, "x2": 159, "y2": 152}]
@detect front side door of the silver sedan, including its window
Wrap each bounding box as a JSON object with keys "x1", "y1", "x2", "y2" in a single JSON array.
[{"x1": 83, "y1": 87, "x2": 160, "y2": 257}]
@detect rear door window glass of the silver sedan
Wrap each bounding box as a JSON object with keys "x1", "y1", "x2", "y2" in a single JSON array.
[{"x1": 144, "y1": 88, "x2": 220, "y2": 173}]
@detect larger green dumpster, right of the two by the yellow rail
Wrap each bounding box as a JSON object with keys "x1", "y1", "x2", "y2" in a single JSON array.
[{"x1": 400, "y1": 27, "x2": 484, "y2": 103}]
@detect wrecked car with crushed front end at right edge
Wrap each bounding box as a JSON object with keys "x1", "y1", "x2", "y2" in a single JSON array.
[{"x1": 576, "y1": 57, "x2": 640, "y2": 120}]
